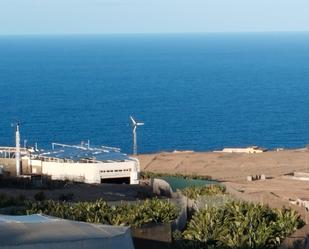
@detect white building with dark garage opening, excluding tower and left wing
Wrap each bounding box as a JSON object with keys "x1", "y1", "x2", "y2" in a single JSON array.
[{"x1": 29, "y1": 143, "x2": 140, "y2": 184}]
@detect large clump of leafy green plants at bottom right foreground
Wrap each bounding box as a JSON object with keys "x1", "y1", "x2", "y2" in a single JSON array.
[{"x1": 178, "y1": 201, "x2": 303, "y2": 249}]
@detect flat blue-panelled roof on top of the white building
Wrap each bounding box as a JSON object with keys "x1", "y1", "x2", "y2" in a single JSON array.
[{"x1": 33, "y1": 143, "x2": 133, "y2": 161}]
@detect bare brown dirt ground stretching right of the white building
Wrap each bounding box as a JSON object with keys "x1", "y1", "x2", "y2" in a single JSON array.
[{"x1": 138, "y1": 149, "x2": 309, "y2": 219}]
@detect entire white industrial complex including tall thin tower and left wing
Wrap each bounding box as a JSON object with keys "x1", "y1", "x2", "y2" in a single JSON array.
[{"x1": 0, "y1": 124, "x2": 140, "y2": 184}]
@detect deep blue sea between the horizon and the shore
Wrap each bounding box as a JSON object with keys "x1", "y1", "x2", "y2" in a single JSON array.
[{"x1": 0, "y1": 33, "x2": 309, "y2": 153}]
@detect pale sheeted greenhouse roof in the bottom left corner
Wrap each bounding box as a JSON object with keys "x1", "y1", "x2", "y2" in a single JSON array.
[{"x1": 0, "y1": 214, "x2": 134, "y2": 249}]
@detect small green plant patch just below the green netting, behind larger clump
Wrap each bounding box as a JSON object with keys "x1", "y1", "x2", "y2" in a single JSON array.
[{"x1": 181, "y1": 184, "x2": 225, "y2": 200}]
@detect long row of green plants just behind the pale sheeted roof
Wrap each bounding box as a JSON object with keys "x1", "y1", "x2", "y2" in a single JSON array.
[{"x1": 25, "y1": 198, "x2": 179, "y2": 227}]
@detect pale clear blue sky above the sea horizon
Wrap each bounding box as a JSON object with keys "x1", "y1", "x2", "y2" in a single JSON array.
[{"x1": 0, "y1": 0, "x2": 309, "y2": 35}]
